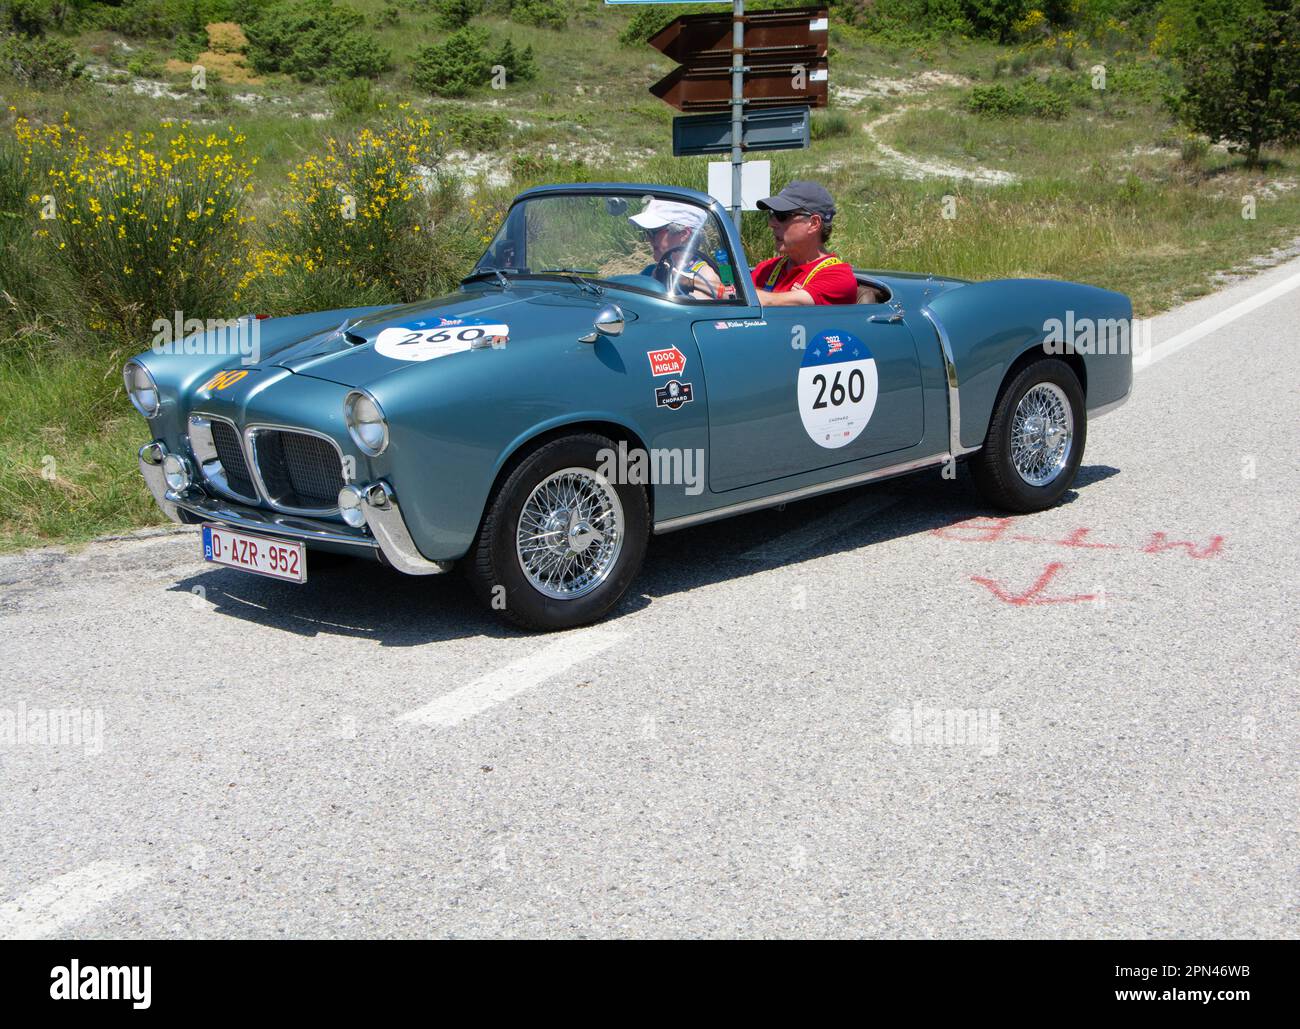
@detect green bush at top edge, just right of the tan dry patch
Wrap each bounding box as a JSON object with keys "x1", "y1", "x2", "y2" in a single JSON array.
[{"x1": 246, "y1": 0, "x2": 391, "y2": 82}]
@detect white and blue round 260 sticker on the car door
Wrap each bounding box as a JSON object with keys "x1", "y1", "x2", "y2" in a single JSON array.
[{"x1": 798, "y1": 331, "x2": 879, "y2": 450}]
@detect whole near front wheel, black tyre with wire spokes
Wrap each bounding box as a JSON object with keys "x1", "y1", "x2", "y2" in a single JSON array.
[{"x1": 465, "y1": 434, "x2": 650, "y2": 630}]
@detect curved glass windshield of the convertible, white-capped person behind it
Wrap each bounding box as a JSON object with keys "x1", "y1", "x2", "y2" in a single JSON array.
[{"x1": 471, "y1": 194, "x2": 736, "y2": 304}]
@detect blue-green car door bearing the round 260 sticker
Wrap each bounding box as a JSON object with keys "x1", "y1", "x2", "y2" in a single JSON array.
[{"x1": 693, "y1": 304, "x2": 924, "y2": 492}]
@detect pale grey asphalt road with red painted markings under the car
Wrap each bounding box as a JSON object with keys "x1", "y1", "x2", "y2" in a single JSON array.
[{"x1": 0, "y1": 254, "x2": 1300, "y2": 938}]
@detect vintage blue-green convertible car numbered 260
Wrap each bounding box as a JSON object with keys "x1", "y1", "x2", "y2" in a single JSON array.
[{"x1": 125, "y1": 183, "x2": 1132, "y2": 629}]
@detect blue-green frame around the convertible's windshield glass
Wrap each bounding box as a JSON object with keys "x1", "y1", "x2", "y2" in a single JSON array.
[{"x1": 467, "y1": 182, "x2": 758, "y2": 309}]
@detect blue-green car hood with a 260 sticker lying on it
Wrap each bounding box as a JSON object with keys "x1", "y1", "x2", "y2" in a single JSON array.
[{"x1": 272, "y1": 287, "x2": 613, "y2": 387}]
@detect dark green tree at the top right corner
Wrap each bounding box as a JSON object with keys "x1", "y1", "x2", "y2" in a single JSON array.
[{"x1": 1174, "y1": 0, "x2": 1300, "y2": 166}]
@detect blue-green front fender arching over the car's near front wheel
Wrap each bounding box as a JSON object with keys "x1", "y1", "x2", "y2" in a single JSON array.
[{"x1": 358, "y1": 305, "x2": 709, "y2": 561}]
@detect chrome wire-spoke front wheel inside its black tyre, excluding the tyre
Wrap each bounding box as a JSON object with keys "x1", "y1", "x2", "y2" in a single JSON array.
[{"x1": 515, "y1": 468, "x2": 625, "y2": 600}]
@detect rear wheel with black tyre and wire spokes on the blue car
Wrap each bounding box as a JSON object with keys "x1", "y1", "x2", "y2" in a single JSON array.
[{"x1": 970, "y1": 357, "x2": 1088, "y2": 513}]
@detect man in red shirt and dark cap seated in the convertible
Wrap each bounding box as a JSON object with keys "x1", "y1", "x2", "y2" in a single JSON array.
[{"x1": 754, "y1": 181, "x2": 858, "y2": 307}]
